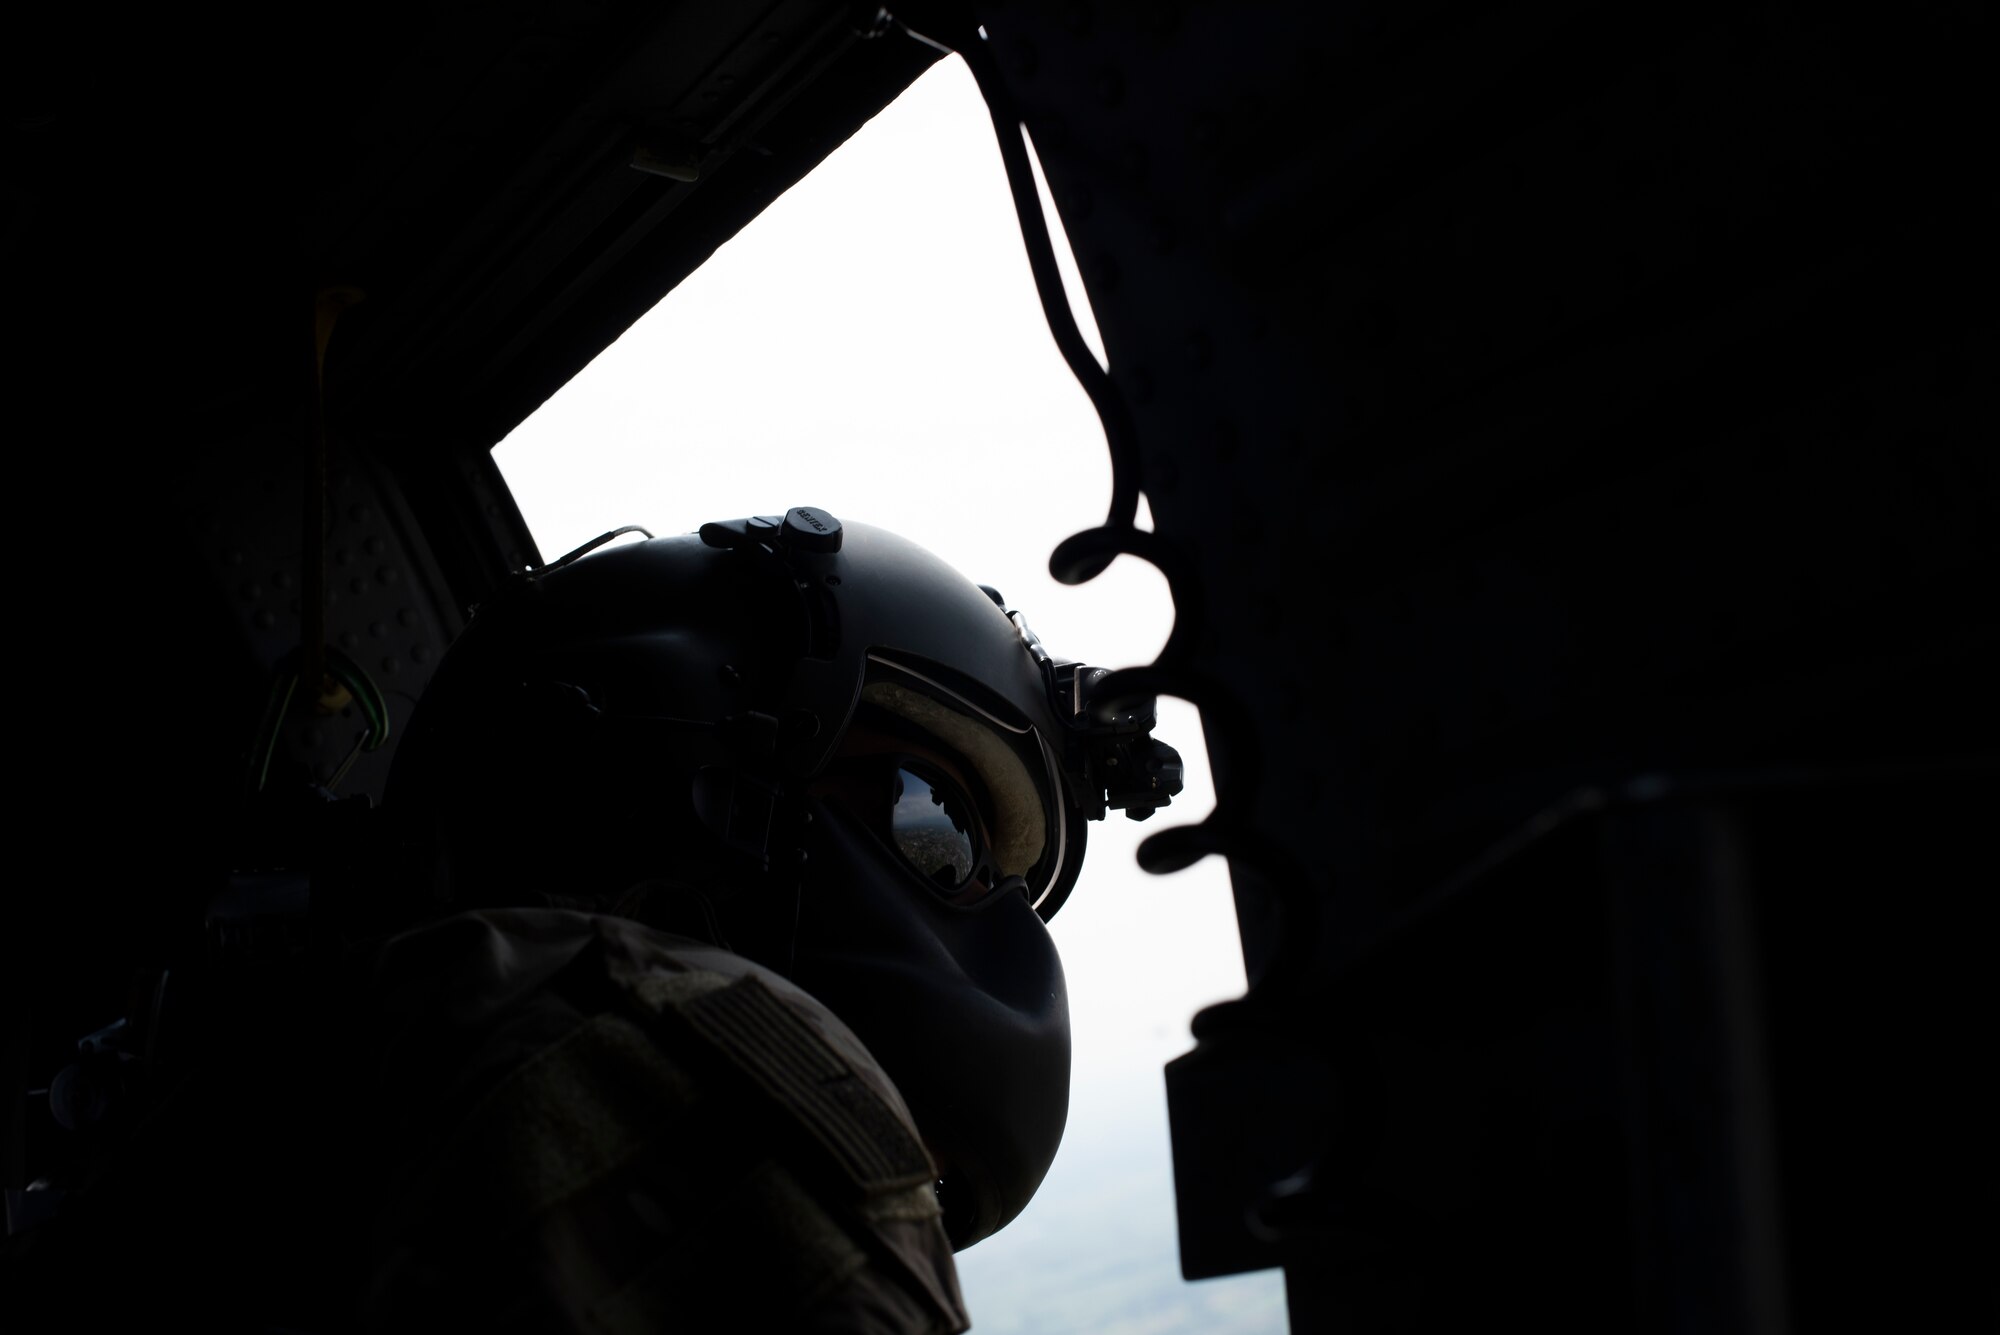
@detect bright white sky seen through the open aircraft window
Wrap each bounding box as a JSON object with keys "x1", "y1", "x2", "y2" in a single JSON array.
[{"x1": 496, "y1": 58, "x2": 1286, "y2": 1335}]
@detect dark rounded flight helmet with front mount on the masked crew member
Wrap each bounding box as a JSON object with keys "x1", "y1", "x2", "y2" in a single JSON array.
[{"x1": 388, "y1": 508, "x2": 1180, "y2": 921}]
